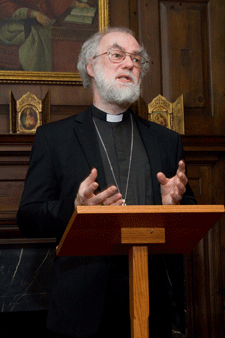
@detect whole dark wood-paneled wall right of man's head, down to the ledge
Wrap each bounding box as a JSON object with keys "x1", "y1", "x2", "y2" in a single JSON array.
[{"x1": 137, "y1": 0, "x2": 225, "y2": 135}]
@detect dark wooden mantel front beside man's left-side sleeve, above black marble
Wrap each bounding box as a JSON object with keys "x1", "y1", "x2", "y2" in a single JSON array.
[{"x1": 0, "y1": 134, "x2": 55, "y2": 248}]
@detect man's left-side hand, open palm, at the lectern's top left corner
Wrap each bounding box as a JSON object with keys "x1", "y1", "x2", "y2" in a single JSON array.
[{"x1": 74, "y1": 168, "x2": 123, "y2": 207}]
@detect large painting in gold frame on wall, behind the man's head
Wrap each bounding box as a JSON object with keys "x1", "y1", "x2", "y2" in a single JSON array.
[{"x1": 0, "y1": 0, "x2": 109, "y2": 84}]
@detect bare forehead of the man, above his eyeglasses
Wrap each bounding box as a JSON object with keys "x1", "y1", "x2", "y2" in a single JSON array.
[{"x1": 100, "y1": 32, "x2": 141, "y2": 52}]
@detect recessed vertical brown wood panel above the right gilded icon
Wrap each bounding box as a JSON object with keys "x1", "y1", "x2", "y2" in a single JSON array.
[{"x1": 160, "y1": 1, "x2": 212, "y2": 134}]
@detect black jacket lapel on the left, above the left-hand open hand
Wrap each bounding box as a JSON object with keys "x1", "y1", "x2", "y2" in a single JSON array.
[{"x1": 74, "y1": 107, "x2": 106, "y2": 190}]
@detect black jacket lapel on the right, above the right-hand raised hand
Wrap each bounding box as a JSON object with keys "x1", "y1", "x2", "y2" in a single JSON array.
[{"x1": 134, "y1": 115, "x2": 162, "y2": 205}]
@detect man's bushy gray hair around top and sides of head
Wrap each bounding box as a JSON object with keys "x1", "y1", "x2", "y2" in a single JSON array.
[{"x1": 77, "y1": 27, "x2": 149, "y2": 88}]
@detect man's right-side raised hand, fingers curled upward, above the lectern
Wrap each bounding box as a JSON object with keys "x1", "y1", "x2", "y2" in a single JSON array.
[{"x1": 157, "y1": 160, "x2": 188, "y2": 205}]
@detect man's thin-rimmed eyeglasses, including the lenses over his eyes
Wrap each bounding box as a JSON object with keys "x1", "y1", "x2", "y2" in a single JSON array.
[{"x1": 93, "y1": 49, "x2": 148, "y2": 68}]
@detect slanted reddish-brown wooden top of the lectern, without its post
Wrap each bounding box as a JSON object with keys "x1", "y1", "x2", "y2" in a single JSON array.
[{"x1": 56, "y1": 205, "x2": 224, "y2": 256}]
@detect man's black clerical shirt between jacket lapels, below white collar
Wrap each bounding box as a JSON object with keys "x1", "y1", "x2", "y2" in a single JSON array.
[{"x1": 92, "y1": 106, "x2": 153, "y2": 205}]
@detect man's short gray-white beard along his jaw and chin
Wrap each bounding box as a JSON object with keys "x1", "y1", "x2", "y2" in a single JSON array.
[{"x1": 94, "y1": 64, "x2": 141, "y2": 105}]
